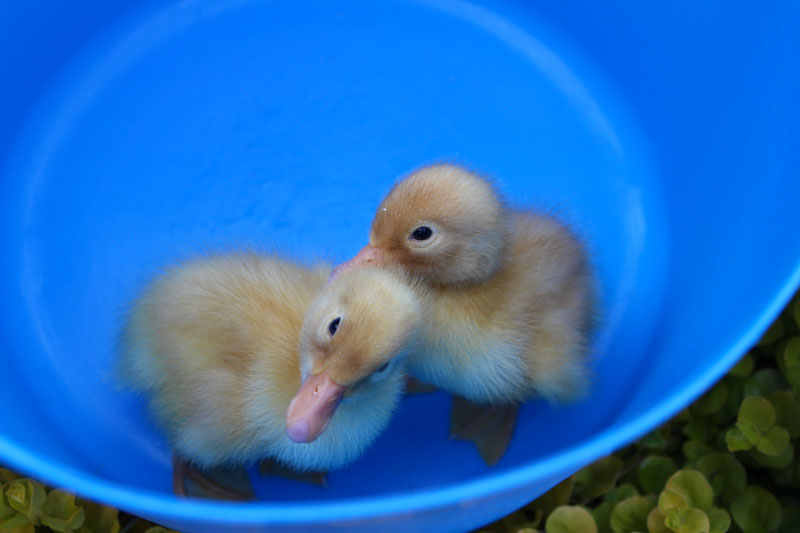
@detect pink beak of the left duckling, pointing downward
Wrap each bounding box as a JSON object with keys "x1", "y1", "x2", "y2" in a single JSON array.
[{"x1": 286, "y1": 372, "x2": 347, "y2": 443}]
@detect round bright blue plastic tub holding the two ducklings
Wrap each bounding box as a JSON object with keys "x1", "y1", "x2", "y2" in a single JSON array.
[{"x1": 0, "y1": 0, "x2": 800, "y2": 531}]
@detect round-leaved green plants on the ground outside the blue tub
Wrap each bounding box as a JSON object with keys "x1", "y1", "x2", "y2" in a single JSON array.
[{"x1": 0, "y1": 294, "x2": 800, "y2": 533}]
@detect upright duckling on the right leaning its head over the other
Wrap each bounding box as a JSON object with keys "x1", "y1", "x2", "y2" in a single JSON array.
[{"x1": 332, "y1": 164, "x2": 594, "y2": 464}]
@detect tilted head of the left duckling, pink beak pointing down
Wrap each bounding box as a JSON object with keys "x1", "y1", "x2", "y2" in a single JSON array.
[{"x1": 286, "y1": 267, "x2": 421, "y2": 442}]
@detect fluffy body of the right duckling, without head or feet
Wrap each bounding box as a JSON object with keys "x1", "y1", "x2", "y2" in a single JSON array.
[{"x1": 408, "y1": 212, "x2": 591, "y2": 404}]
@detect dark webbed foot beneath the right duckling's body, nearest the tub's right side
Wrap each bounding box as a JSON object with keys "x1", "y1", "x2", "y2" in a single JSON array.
[{"x1": 450, "y1": 396, "x2": 519, "y2": 466}]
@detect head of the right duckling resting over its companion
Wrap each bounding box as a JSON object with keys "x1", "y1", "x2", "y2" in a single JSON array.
[{"x1": 332, "y1": 164, "x2": 508, "y2": 284}]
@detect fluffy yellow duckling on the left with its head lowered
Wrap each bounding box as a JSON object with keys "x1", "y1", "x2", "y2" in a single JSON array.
[{"x1": 119, "y1": 253, "x2": 420, "y2": 498}]
